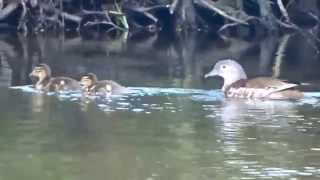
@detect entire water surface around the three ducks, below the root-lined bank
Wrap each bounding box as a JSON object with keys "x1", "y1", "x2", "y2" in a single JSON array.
[{"x1": 0, "y1": 31, "x2": 320, "y2": 180}]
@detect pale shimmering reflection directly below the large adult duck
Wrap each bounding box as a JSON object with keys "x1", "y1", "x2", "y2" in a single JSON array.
[{"x1": 209, "y1": 99, "x2": 299, "y2": 155}]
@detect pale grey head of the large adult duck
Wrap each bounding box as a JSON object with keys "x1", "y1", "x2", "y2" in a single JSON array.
[{"x1": 204, "y1": 59, "x2": 247, "y2": 91}]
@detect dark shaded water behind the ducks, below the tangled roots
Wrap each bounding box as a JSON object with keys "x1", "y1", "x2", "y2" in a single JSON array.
[{"x1": 0, "y1": 33, "x2": 320, "y2": 88}]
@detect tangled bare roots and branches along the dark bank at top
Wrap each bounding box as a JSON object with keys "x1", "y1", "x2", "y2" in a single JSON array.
[{"x1": 0, "y1": 0, "x2": 320, "y2": 44}]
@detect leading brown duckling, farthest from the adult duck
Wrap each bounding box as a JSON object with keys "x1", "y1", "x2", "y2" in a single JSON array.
[{"x1": 29, "y1": 63, "x2": 80, "y2": 92}]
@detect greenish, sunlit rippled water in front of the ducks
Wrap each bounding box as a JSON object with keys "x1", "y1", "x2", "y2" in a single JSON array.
[{"x1": 4, "y1": 82, "x2": 320, "y2": 179}]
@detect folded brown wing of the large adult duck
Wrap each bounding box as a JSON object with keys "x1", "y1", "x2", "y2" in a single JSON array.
[{"x1": 246, "y1": 77, "x2": 298, "y2": 94}]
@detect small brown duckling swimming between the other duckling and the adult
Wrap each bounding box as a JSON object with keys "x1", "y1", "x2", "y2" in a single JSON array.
[{"x1": 80, "y1": 73, "x2": 127, "y2": 96}]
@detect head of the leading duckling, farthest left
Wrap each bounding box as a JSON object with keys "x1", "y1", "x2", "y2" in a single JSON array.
[{"x1": 29, "y1": 64, "x2": 51, "y2": 85}]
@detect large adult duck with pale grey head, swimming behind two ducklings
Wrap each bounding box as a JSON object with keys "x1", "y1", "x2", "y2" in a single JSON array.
[{"x1": 204, "y1": 59, "x2": 303, "y2": 100}]
